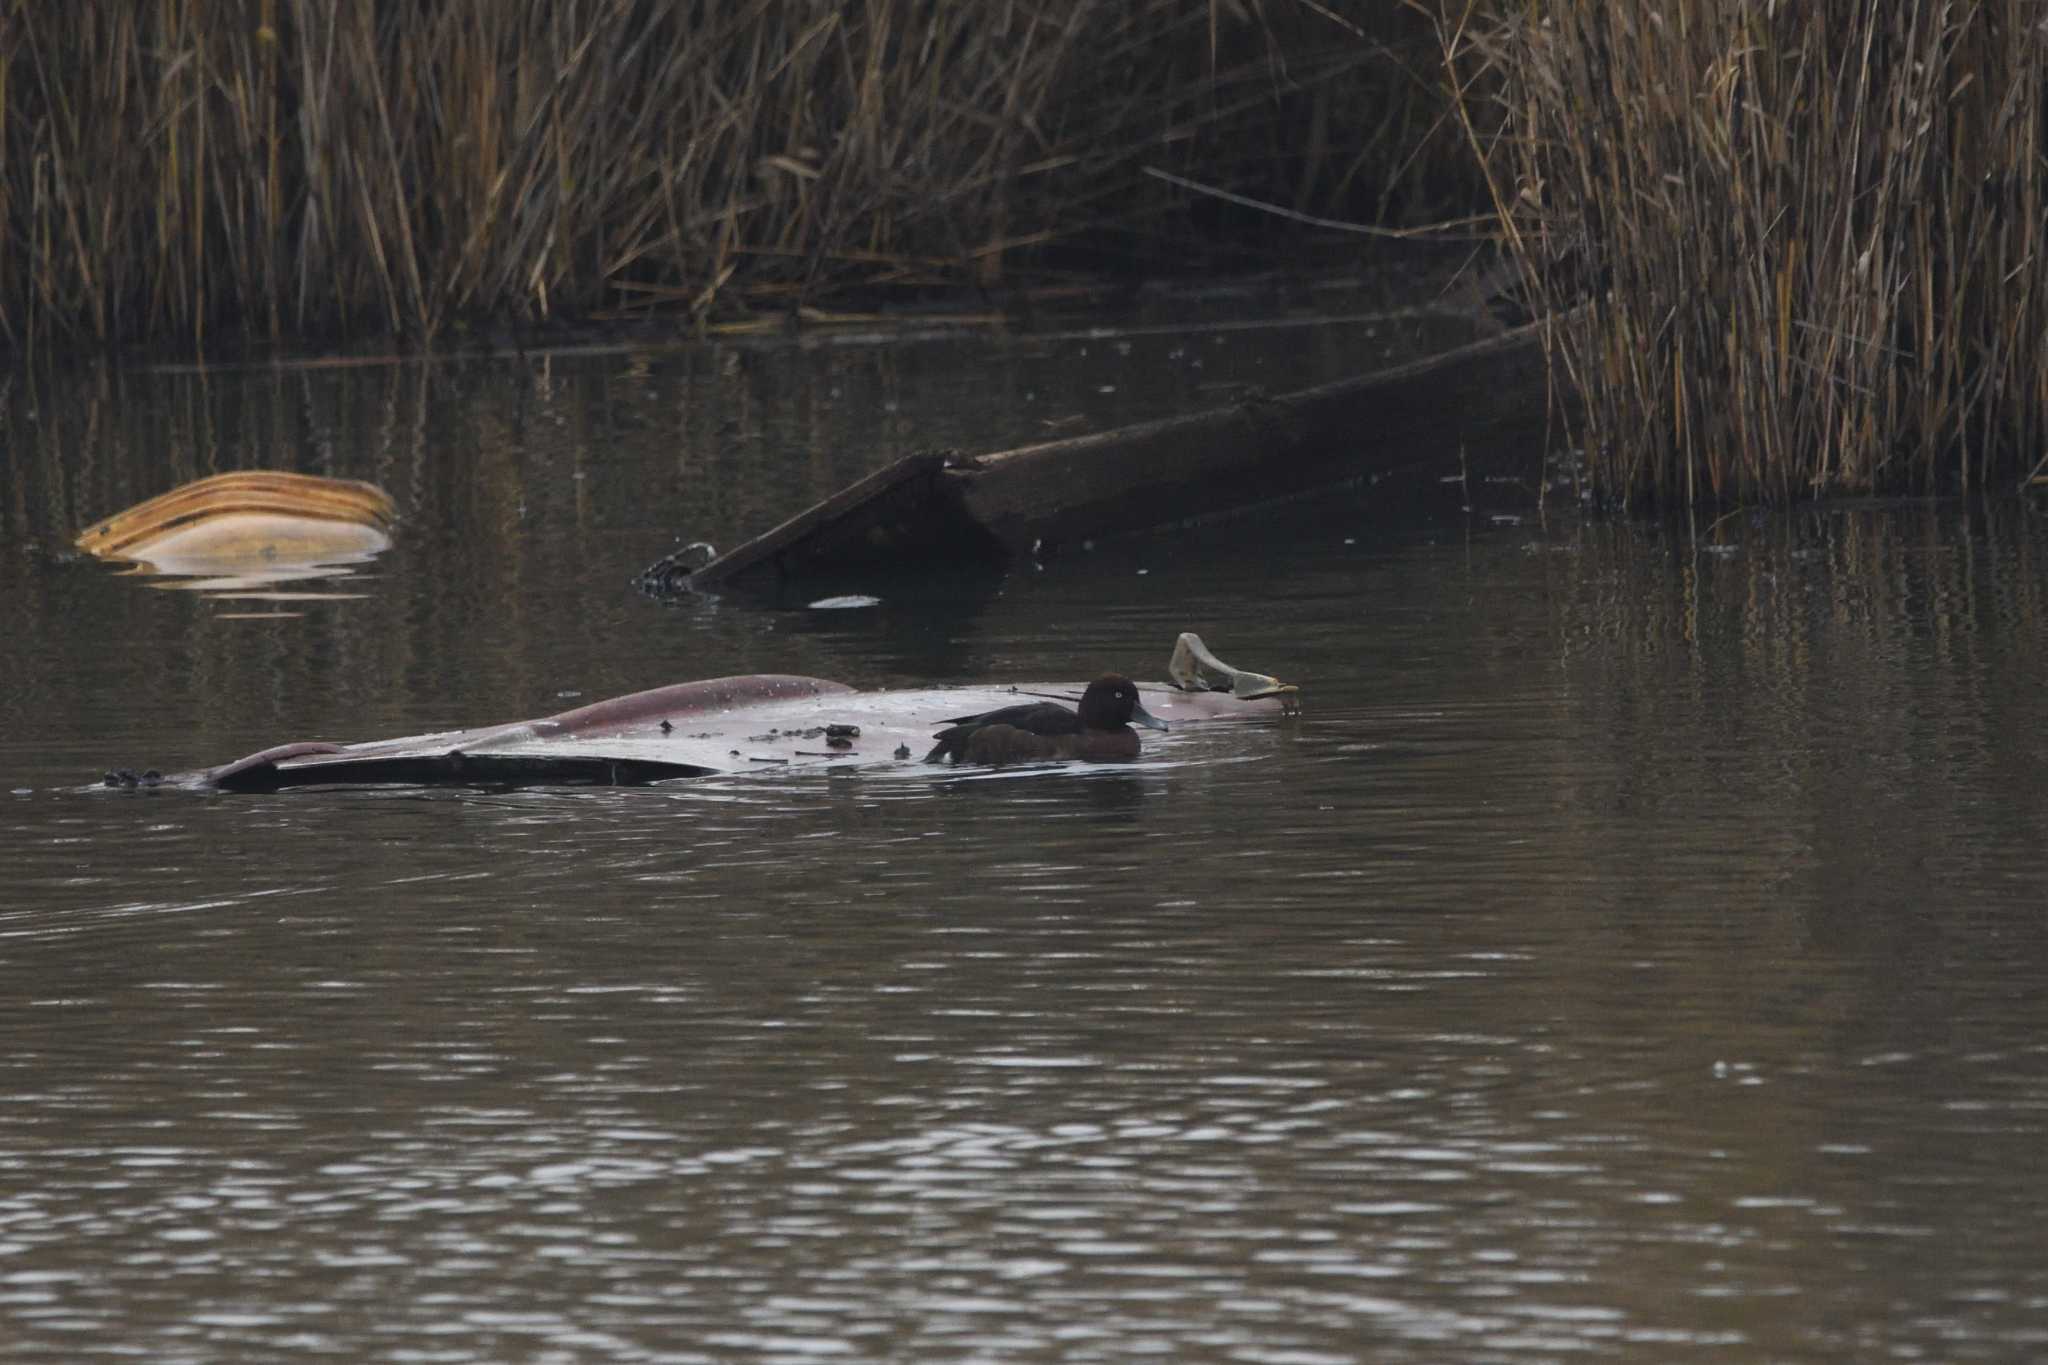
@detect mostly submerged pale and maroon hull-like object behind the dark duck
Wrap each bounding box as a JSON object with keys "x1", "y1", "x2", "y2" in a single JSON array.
[{"x1": 148, "y1": 632, "x2": 1300, "y2": 792}]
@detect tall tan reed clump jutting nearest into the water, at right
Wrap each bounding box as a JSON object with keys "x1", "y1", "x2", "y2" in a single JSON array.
[{"x1": 1444, "y1": 0, "x2": 2048, "y2": 505}]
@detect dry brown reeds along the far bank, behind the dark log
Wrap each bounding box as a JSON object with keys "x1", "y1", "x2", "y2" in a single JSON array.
[{"x1": 0, "y1": 0, "x2": 1470, "y2": 348}]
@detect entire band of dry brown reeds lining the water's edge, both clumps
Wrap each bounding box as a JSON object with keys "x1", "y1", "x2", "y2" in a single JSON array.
[{"x1": 0, "y1": 0, "x2": 2048, "y2": 505}]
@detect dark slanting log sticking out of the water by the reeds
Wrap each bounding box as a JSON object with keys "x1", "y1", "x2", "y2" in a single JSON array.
[{"x1": 671, "y1": 323, "x2": 1550, "y2": 589}]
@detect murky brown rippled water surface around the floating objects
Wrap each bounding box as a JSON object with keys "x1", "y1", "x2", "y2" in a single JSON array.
[{"x1": 0, "y1": 294, "x2": 2048, "y2": 1363}]
